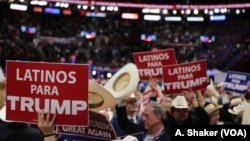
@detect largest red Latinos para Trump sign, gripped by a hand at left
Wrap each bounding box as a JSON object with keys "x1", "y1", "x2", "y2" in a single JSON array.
[{"x1": 6, "y1": 61, "x2": 88, "y2": 126}]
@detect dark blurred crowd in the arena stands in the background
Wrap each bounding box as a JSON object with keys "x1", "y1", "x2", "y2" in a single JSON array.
[{"x1": 0, "y1": 6, "x2": 250, "y2": 76}]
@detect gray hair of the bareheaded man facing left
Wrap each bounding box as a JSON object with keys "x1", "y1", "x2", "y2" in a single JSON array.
[{"x1": 147, "y1": 101, "x2": 167, "y2": 120}]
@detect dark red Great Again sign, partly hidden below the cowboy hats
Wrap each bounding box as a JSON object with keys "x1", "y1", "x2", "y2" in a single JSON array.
[{"x1": 57, "y1": 110, "x2": 116, "y2": 140}]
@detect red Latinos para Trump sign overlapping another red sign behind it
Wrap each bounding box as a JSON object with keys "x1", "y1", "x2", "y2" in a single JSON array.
[{"x1": 163, "y1": 60, "x2": 207, "y2": 94}]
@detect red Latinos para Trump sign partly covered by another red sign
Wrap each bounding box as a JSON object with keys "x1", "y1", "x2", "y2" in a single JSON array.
[{"x1": 133, "y1": 49, "x2": 176, "y2": 80}]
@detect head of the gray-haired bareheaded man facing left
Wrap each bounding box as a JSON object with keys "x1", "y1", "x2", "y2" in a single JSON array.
[{"x1": 142, "y1": 101, "x2": 166, "y2": 130}]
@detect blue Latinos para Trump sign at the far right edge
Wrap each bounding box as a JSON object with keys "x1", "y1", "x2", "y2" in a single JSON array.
[{"x1": 224, "y1": 71, "x2": 250, "y2": 94}]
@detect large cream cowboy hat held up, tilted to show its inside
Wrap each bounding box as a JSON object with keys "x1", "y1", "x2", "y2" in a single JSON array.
[{"x1": 104, "y1": 63, "x2": 139, "y2": 100}]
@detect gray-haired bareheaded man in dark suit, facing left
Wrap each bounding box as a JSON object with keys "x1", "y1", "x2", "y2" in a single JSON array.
[{"x1": 116, "y1": 101, "x2": 170, "y2": 141}]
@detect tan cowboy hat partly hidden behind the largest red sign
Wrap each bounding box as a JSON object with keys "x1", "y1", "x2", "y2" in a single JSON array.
[{"x1": 88, "y1": 80, "x2": 116, "y2": 112}]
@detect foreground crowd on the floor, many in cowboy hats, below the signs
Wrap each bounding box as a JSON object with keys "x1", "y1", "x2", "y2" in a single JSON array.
[{"x1": 0, "y1": 69, "x2": 250, "y2": 141}]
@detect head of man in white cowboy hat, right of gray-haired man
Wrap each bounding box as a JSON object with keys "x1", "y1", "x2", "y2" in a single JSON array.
[{"x1": 171, "y1": 95, "x2": 189, "y2": 125}]
